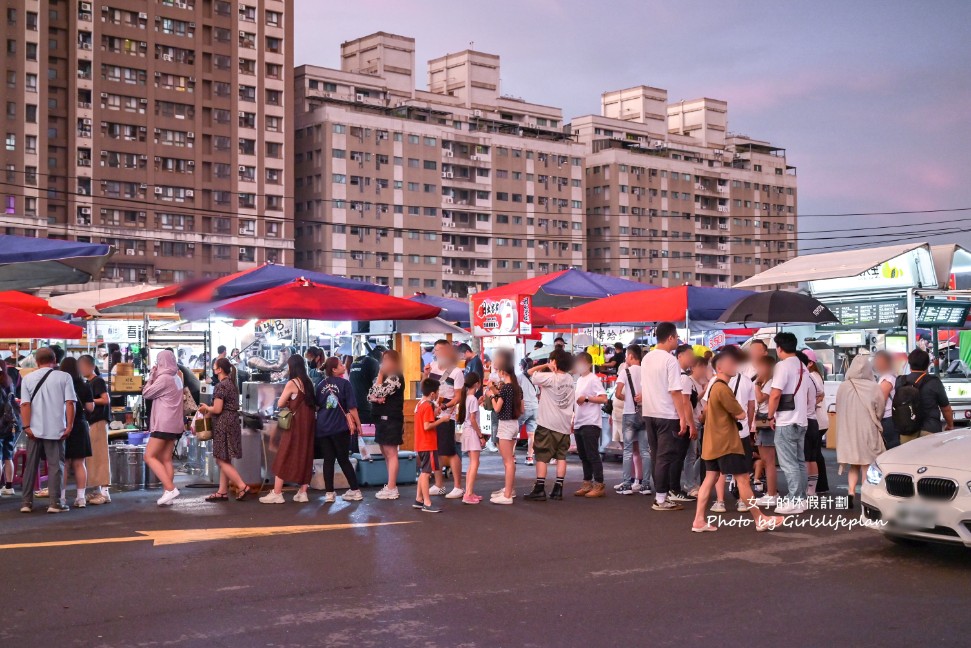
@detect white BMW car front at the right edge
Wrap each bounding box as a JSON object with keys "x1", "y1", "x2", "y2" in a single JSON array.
[{"x1": 861, "y1": 428, "x2": 971, "y2": 548}]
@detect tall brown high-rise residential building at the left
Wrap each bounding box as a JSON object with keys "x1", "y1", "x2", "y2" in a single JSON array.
[{"x1": 0, "y1": 0, "x2": 293, "y2": 283}]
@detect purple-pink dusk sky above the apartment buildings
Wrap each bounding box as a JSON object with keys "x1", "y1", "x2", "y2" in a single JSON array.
[{"x1": 294, "y1": 0, "x2": 971, "y2": 251}]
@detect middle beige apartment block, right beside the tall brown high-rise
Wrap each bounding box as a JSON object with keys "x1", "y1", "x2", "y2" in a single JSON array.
[{"x1": 294, "y1": 32, "x2": 586, "y2": 297}]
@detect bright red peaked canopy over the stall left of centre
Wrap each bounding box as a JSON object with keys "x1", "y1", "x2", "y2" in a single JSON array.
[{"x1": 214, "y1": 279, "x2": 442, "y2": 322}]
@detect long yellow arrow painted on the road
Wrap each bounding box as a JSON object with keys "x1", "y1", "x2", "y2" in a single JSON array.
[{"x1": 0, "y1": 522, "x2": 414, "y2": 550}]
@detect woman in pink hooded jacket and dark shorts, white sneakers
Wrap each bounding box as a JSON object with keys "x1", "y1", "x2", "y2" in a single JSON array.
[{"x1": 142, "y1": 351, "x2": 185, "y2": 506}]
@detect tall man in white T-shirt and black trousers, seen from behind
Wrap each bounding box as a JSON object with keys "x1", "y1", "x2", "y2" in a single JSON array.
[{"x1": 637, "y1": 322, "x2": 698, "y2": 511}]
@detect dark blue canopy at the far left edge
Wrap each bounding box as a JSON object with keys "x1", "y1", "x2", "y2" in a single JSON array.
[{"x1": 0, "y1": 234, "x2": 113, "y2": 290}]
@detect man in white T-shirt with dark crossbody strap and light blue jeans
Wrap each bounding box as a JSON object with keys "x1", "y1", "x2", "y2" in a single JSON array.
[{"x1": 614, "y1": 344, "x2": 651, "y2": 495}]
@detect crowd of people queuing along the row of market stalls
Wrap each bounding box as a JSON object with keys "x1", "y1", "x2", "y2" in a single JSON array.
[{"x1": 0, "y1": 323, "x2": 953, "y2": 532}]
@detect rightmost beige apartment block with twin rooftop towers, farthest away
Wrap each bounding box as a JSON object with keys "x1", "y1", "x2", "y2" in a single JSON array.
[{"x1": 570, "y1": 86, "x2": 797, "y2": 287}]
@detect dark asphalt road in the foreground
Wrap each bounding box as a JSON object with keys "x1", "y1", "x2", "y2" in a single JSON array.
[{"x1": 0, "y1": 456, "x2": 971, "y2": 647}]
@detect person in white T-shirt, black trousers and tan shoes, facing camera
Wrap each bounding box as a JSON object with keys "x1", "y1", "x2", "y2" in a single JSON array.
[{"x1": 557, "y1": 351, "x2": 607, "y2": 498}]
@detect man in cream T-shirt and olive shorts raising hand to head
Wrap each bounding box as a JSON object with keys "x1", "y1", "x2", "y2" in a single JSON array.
[{"x1": 526, "y1": 349, "x2": 575, "y2": 502}]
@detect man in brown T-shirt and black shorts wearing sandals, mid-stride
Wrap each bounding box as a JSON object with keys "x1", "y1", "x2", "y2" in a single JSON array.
[{"x1": 691, "y1": 349, "x2": 785, "y2": 533}]
